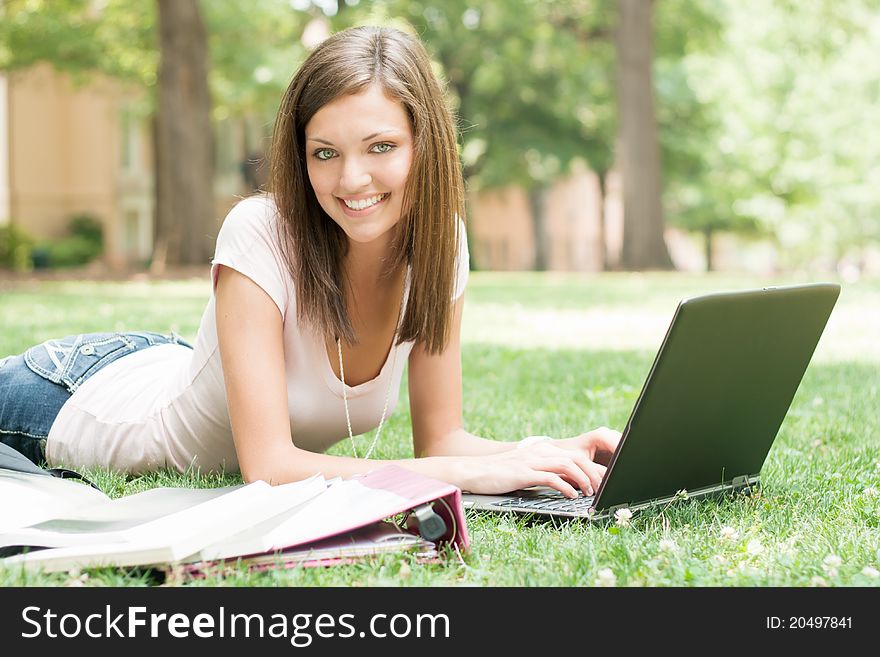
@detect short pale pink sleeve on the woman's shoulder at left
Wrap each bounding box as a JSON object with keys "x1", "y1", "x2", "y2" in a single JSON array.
[{"x1": 211, "y1": 196, "x2": 291, "y2": 317}]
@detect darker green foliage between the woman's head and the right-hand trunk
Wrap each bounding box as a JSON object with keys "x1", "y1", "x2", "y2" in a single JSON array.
[{"x1": 334, "y1": 0, "x2": 614, "y2": 189}]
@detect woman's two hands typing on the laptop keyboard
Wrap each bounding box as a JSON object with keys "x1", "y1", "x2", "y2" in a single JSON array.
[{"x1": 455, "y1": 427, "x2": 620, "y2": 498}]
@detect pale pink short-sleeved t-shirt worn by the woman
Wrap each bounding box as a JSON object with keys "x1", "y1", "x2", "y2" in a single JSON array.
[{"x1": 46, "y1": 196, "x2": 468, "y2": 473}]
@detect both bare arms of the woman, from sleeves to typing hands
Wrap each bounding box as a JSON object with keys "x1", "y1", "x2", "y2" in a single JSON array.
[{"x1": 216, "y1": 267, "x2": 620, "y2": 496}]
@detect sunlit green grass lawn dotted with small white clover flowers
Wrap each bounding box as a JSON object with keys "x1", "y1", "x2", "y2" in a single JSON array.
[{"x1": 0, "y1": 273, "x2": 880, "y2": 586}]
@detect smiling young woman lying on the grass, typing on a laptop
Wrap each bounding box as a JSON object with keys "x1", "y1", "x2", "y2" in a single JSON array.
[{"x1": 0, "y1": 27, "x2": 620, "y2": 497}]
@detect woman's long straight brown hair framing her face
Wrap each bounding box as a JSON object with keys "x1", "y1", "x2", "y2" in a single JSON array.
[{"x1": 269, "y1": 27, "x2": 467, "y2": 353}]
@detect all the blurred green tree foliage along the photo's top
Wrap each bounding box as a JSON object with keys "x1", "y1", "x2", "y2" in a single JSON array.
[{"x1": 0, "y1": 0, "x2": 880, "y2": 265}]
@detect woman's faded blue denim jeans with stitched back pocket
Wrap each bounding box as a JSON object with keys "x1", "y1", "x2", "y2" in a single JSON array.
[{"x1": 0, "y1": 332, "x2": 190, "y2": 463}]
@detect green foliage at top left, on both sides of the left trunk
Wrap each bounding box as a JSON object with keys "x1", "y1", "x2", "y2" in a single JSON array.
[{"x1": 0, "y1": 0, "x2": 308, "y2": 118}]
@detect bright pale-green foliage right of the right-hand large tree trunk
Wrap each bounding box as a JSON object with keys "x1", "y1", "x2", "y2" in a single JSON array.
[{"x1": 683, "y1": 0, "x2": 880, "y2": 266}]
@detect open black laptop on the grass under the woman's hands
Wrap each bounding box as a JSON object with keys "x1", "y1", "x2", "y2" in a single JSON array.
[{"x1": 463, "y1": 283, "x2": 840, "y2": 519}]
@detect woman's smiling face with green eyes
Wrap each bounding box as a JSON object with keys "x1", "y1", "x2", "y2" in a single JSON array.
[{"x1": 305, "y1": 85, "x2": 413, "y2": 249}]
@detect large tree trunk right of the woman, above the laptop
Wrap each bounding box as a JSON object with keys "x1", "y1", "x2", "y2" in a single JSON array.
[{"x1": 615, "y1": 0, "x2": 673, "y2": 269}]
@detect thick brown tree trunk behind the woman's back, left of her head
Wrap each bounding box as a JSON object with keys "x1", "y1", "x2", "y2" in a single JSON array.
[{"x1": 153, "y1": 0, "x2": 217, "y2": 271}]
